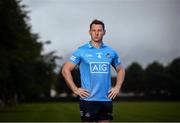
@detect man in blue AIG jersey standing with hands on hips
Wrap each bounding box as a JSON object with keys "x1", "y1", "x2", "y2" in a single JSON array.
[{"x1": 62, "y1": 20, "x2": 124, "y2": 122}]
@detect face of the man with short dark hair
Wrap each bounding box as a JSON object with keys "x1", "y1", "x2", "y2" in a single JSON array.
[{"x1": 89, "y1": 24, "x2": 105, "y2": 42}]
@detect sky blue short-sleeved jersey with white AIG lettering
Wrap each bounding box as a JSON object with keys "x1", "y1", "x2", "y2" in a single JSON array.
[{"x1": 69, "y1": 42, "x2": 121, "y2": 101}]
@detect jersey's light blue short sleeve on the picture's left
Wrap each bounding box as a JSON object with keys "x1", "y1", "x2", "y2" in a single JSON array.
[{"x1": 69, "y1": 50, "x2": 80, "y2": 65}]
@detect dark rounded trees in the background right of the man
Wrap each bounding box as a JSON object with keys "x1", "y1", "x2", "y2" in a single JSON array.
[{"x1": 122, "y1": 58, "x2": 180, "y2": 99}]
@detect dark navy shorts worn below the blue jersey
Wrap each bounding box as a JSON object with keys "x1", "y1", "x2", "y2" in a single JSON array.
[{"x1": 80, "y1": 100, "x2": 113, "y2": 122}]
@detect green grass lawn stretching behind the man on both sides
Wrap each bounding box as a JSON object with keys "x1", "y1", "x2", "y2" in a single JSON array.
[{"x1": 0, "y1": 102, "x2": 180, "y2": 122}]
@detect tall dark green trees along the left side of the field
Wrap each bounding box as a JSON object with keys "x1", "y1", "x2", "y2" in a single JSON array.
[{"x1": 0, "y1": 0, "x2": 55, "y2": 104}]
